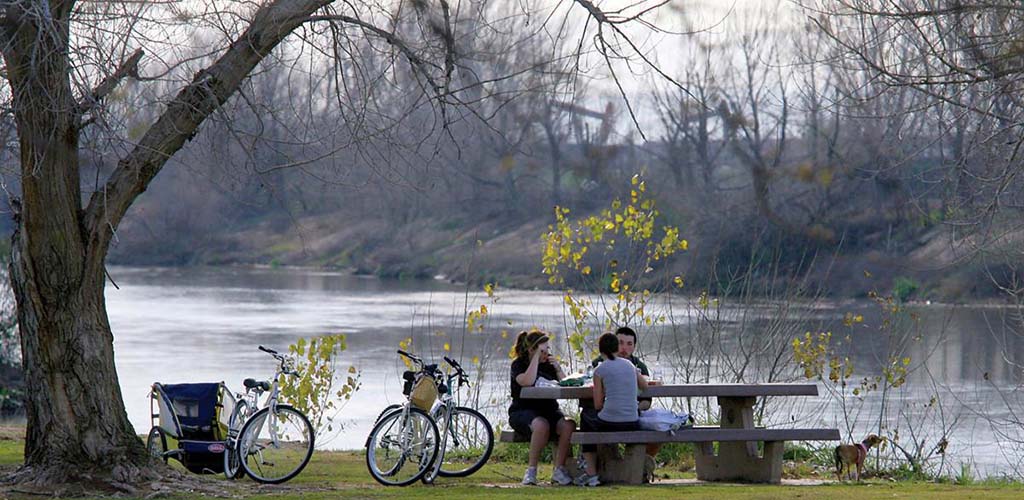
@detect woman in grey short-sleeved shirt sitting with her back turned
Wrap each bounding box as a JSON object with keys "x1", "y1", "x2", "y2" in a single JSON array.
[{"x1": 575, "y1": 333, "x2": 647, "y2": 486}]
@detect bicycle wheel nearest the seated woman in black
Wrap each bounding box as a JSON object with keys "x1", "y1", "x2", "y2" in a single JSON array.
[{"x1": 437, "y1": 407, "x2": 495, "y2": 477}]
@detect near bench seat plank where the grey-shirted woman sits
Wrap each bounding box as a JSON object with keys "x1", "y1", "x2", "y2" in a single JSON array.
[{"x1": 572, "y1": 427, "x2": 840, "y2": 445}]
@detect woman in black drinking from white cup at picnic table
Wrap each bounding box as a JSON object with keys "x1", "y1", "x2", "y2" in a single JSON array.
[{"x1": 509, "y1": 330, "x2": 575, "y2": 486}]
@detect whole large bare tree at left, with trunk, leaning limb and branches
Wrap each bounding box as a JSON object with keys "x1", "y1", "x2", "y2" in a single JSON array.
[{"x1": 0, "y1": 0, "x2": 688, "y2": 485}]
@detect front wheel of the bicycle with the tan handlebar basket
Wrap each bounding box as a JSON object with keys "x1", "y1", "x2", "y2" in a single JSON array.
[{"x1": 367, "y1": 408, "x2": 440, "y2": 486}]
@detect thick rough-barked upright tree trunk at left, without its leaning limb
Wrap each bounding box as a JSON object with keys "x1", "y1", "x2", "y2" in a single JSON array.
[{"x1": 4, "y1": 2, "x2": 147, "y2": 483}]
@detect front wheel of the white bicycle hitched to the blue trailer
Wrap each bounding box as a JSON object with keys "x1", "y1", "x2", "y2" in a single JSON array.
[{"x1": 238, "y1": 405, "x2": 314, "y2": 485}]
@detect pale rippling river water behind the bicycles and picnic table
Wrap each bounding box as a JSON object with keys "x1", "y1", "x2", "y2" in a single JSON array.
[{"x1": 106, "y1": 267, "x2": 1024, "y2": 475}]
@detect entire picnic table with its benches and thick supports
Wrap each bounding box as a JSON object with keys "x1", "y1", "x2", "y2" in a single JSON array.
[{"x1": 501, "y1": 383, "x2": 840, "y2": 484}]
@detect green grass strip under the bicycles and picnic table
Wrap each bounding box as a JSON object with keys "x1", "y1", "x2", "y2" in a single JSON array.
[{"x1": 0, "y1": 428, "x2": 1024, "y2": 500}]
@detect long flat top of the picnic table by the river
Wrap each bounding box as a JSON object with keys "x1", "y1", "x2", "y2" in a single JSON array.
[{"x1": 520, "y1": 383, "x2": 818, "y2": 400}]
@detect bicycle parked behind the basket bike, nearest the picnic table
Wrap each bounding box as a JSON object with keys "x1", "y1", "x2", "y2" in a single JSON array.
[{"x1": 370, "y1": 351, "x2": 495, "y2": 484}]
